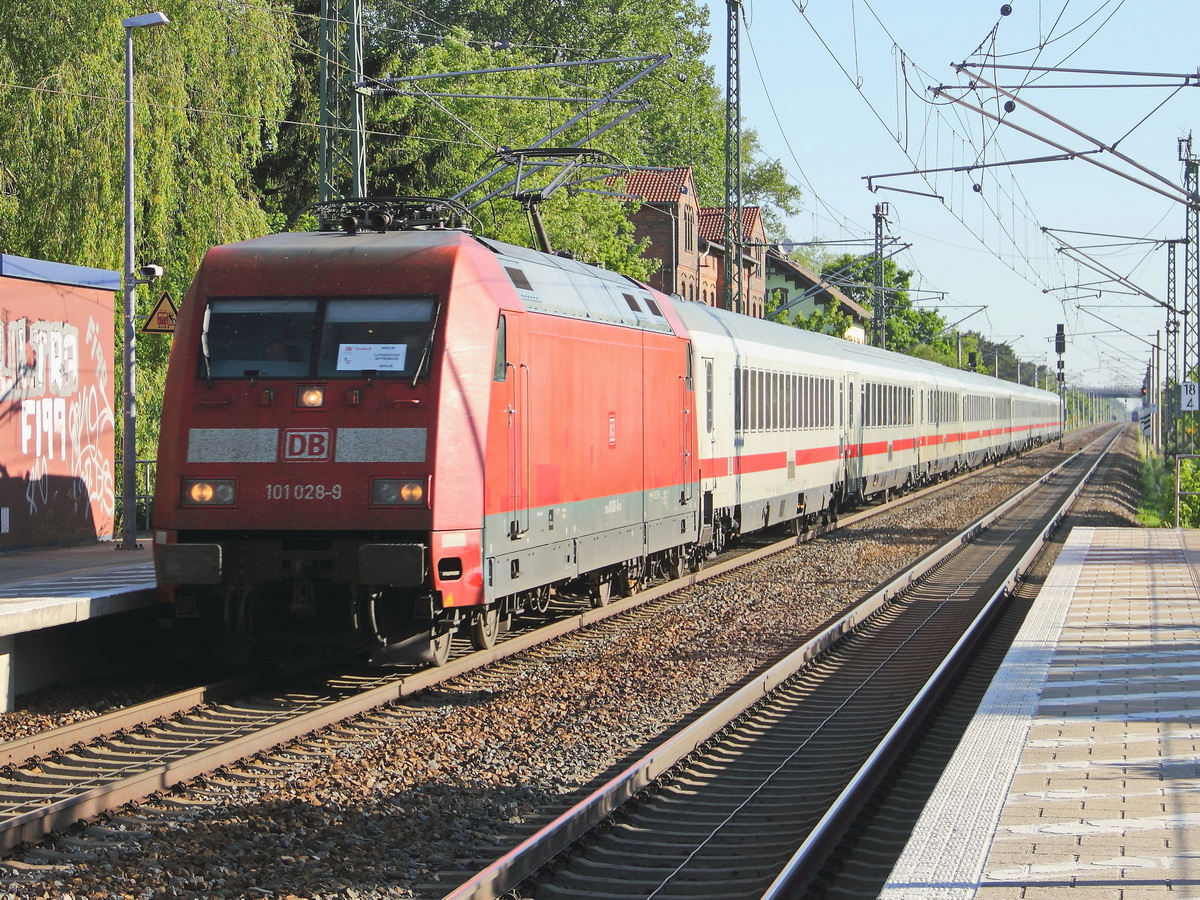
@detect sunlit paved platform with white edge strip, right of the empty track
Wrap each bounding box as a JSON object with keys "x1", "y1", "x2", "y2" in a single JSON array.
[{"x1": 880, "y1": 528, "x2": 1200, "y2": 900}]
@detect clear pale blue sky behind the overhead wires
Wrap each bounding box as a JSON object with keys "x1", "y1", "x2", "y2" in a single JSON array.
[{"x1": 709, "y1": 0, "x2": 1200, "y2": 388}]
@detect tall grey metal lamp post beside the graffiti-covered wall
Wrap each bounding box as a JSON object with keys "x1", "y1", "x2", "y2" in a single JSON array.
[{"x1": 120, "y1": 12, "x2": 170, "y2": 550}]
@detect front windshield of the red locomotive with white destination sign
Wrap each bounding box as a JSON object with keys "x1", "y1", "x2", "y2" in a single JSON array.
[{"x1": 199, "y1": 296, "x2": 437, "y2": 378}]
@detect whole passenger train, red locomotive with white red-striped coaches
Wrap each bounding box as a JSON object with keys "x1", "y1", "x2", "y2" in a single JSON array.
[{"x1": 152, "y1": 199, "x2": 1061, "y2": 665}]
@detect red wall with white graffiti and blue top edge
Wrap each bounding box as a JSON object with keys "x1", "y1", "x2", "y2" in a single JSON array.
[{"x1": 0, "y1": 254, "x2": 120, "y2": 550}]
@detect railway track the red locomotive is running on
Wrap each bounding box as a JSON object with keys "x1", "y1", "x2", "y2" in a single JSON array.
[{"x1": 0, "y1": 436, "x2": 1104, "y2": 873}]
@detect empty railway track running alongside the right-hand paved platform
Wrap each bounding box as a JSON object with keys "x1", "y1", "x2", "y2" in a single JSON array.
[{"x1": 446, "y1": 427, "x2": 1111, "y2": 900}]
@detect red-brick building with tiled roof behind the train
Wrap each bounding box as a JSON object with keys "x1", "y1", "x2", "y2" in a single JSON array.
[{"x1": 610, "y1": 166, "x2": 767, "y2": 318}]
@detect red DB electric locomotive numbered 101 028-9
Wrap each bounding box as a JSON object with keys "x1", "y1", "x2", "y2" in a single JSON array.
[{"x1": 154, "y1": 203, "x2": 703, "y2": 661}]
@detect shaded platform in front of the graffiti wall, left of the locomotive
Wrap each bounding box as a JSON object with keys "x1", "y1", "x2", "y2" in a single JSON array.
[{"x1": 0, "y1": 540, "x2": 157, "y2": 712}]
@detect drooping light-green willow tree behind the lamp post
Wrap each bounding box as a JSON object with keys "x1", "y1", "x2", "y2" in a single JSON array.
[{"x1": 0, "y1": 0, "x2": 293, "y2": 458}]
